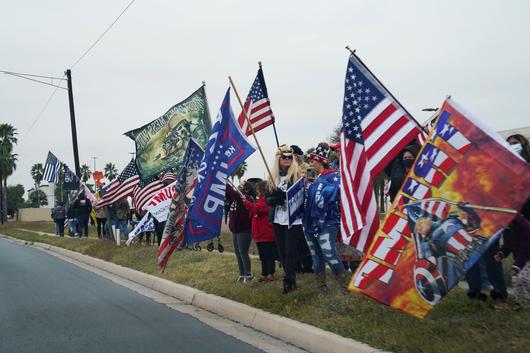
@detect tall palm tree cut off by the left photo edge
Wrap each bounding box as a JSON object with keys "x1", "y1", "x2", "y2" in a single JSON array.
[{"x1": 0, "y1": 123, "x2": 18, "y2": 224}]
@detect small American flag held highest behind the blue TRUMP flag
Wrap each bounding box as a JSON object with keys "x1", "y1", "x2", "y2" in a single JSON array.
[{"x1": 237, "y1": 66, "x2": 274, "y2": 136}]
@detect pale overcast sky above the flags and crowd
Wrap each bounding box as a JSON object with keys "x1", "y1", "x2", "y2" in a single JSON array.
[{"x1": 0, "y1": 0, "x2": 530, "y2": 189}]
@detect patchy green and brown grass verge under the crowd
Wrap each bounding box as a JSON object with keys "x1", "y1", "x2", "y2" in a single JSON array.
[{"x1": 0, "y1": 222, "x2": 530, "y2": 353}]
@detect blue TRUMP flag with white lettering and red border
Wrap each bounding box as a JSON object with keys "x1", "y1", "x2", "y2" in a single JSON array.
[{"x1": 186, "y1": 88, "x2": 256, "y2": 244}]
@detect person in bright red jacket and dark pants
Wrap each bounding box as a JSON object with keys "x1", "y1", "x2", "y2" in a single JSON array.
[{"x1": 243, "y1": 181, "x2": 276, "y2": 282}]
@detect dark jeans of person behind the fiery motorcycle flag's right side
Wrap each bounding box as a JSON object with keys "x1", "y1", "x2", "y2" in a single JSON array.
[{"x1": 466, "y1": 241, "x2": 508, "y2": 300}]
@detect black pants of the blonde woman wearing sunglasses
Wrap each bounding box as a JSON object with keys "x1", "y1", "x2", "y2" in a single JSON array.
[{"x1": 272, "y1": 223, "x2": 304, "y2": 280}]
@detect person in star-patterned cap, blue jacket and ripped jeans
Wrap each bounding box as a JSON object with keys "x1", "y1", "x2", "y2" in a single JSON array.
[{"x1": 302, "y1": 142, "x2": 347, "y2": 293}]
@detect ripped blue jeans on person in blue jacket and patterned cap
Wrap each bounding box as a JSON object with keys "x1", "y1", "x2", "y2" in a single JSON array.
[{"x1": 305, "y1": 226, "x2": 344, "y2": 275}]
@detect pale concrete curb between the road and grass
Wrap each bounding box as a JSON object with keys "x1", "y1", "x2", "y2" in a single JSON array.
[{"x1": 0, "y1": 235, "x2": 384, "y2": 353}]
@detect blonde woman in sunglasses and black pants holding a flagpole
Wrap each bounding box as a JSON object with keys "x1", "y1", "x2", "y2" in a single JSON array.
[{"x1": 265, "y1": 144, "x2": 304, "y2": 293}]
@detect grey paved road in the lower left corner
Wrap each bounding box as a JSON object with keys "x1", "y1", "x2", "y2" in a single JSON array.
[{"x1": 0, "y1": 239, "x2": 261, "y2": 353}]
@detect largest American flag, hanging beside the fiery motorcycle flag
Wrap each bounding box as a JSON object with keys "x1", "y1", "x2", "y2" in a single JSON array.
[{"x1": 340, "y1": 55, "x2": 420, "y2": 252}]
